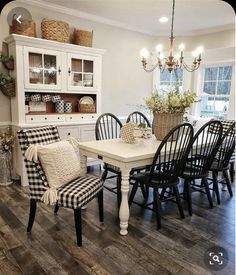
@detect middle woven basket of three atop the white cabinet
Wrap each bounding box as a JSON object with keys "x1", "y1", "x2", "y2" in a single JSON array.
[{"x1": 41, "y1": 19, "x2": 69, "y2": 43}]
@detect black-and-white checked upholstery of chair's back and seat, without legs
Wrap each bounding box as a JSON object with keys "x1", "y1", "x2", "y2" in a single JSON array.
[{"x1": 17, "y1": 126, "x2": 103, "y2": 209}]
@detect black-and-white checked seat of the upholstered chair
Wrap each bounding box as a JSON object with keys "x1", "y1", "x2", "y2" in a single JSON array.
[{"x1": 58, "y1": 176, "x2": 103, "y2": 209}]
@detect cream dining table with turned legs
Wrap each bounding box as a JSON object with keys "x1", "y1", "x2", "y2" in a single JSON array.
[{"x1": 79, "y1": 135, "x2": 164, "y2": 235}]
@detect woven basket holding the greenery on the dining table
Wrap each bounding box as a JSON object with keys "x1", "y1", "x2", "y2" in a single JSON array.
[{"x1": 153, "y1": 112, "x2": 183, "y2": 140}]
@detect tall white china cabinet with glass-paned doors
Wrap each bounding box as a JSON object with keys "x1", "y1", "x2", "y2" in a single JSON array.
[{"x1": 5, "y1": 34, "x2": 105, "y2": 185}]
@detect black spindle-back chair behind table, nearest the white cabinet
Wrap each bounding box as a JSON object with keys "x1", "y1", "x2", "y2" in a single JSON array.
[{"x1": 95, "y1": 113, "x2": 123, "y2": 208}]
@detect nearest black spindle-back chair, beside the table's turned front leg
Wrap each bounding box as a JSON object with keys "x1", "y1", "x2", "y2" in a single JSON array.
[{"x1": 129, "y1": 123, "x2": 193, "y2": 229}]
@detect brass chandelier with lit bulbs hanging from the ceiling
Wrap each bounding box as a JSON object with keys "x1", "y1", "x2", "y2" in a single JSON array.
[{"x1": 141, "y1": 0, "x2": 203, "y2": 72}]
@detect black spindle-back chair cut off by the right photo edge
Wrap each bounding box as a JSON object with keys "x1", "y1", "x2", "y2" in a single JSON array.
[{"x1": 210, "y1": 122, "x2": 235, "y2": 204}]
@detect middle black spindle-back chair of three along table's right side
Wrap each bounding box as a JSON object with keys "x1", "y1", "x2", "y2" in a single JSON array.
[{"x1": 181, "y1": 120, "x2": 222, "y2": 215}]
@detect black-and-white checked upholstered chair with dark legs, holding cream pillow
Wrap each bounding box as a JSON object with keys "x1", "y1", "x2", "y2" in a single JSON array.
[{"x1": 17, "y1": 126, "x2": 103, "y2": 246}]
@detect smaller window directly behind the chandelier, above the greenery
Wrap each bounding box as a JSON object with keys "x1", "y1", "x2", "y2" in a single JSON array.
[{"x1": 159, "y1": 69, "x2": 183, "y2": 92}]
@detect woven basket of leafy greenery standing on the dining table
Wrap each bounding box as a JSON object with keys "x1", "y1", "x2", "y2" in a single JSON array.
[{"x1": 145, "y1": 86, "x2": 198, "y2": 140}]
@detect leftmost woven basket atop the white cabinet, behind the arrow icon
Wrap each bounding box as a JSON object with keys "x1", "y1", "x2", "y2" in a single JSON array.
[{"x1": 10, "y1": 15, "x2": 37, "y2": 37}]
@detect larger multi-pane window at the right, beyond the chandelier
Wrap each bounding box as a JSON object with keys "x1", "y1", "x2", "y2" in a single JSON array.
[{"x1": 200, "y1": 65, "x2": 233, "y2": 118}]
